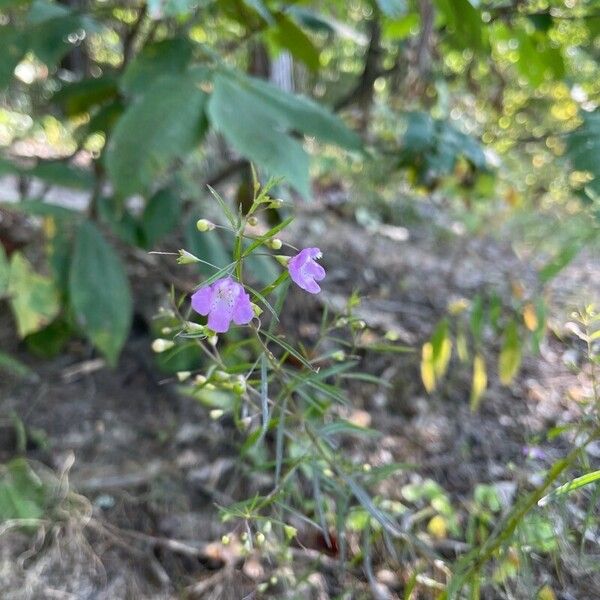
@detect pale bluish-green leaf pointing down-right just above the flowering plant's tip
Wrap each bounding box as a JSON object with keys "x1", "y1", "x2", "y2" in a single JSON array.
[{"x1": 208, "y1": 75, "x2": 310, "y2": 197}]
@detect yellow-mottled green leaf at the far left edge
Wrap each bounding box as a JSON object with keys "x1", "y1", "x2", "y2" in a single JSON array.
[{"x1": 8, "y1": 252, "x2": 60, "y2": 337}]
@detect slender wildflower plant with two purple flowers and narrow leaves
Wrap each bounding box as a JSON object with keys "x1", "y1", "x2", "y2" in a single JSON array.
[{"x1": 155, "y1": 178, "x2": 412, "y2": 584}]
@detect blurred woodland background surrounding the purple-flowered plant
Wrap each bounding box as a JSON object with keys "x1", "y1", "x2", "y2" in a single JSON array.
[{"x1": 0, "y1": 0, "x2": 600, "y2": 600}]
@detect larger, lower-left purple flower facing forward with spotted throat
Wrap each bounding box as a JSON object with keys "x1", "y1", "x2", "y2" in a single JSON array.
[{"x1": 192, "y1": 277, "x2": 254, "y2": 333}]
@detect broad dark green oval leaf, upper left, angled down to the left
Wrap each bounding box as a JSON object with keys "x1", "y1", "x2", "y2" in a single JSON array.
[{"x1": 106, "y1": 75, "x2": 209, "y2": 197}]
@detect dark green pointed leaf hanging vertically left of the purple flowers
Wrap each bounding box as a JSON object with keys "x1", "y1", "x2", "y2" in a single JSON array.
[{"x1": 69, "y1": 221, "x2": 133, "y2": 365}]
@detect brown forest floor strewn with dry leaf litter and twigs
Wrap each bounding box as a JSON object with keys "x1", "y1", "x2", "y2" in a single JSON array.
[{"x1": 0, "y1": 185, "x2": 600, "y2": 600}]
